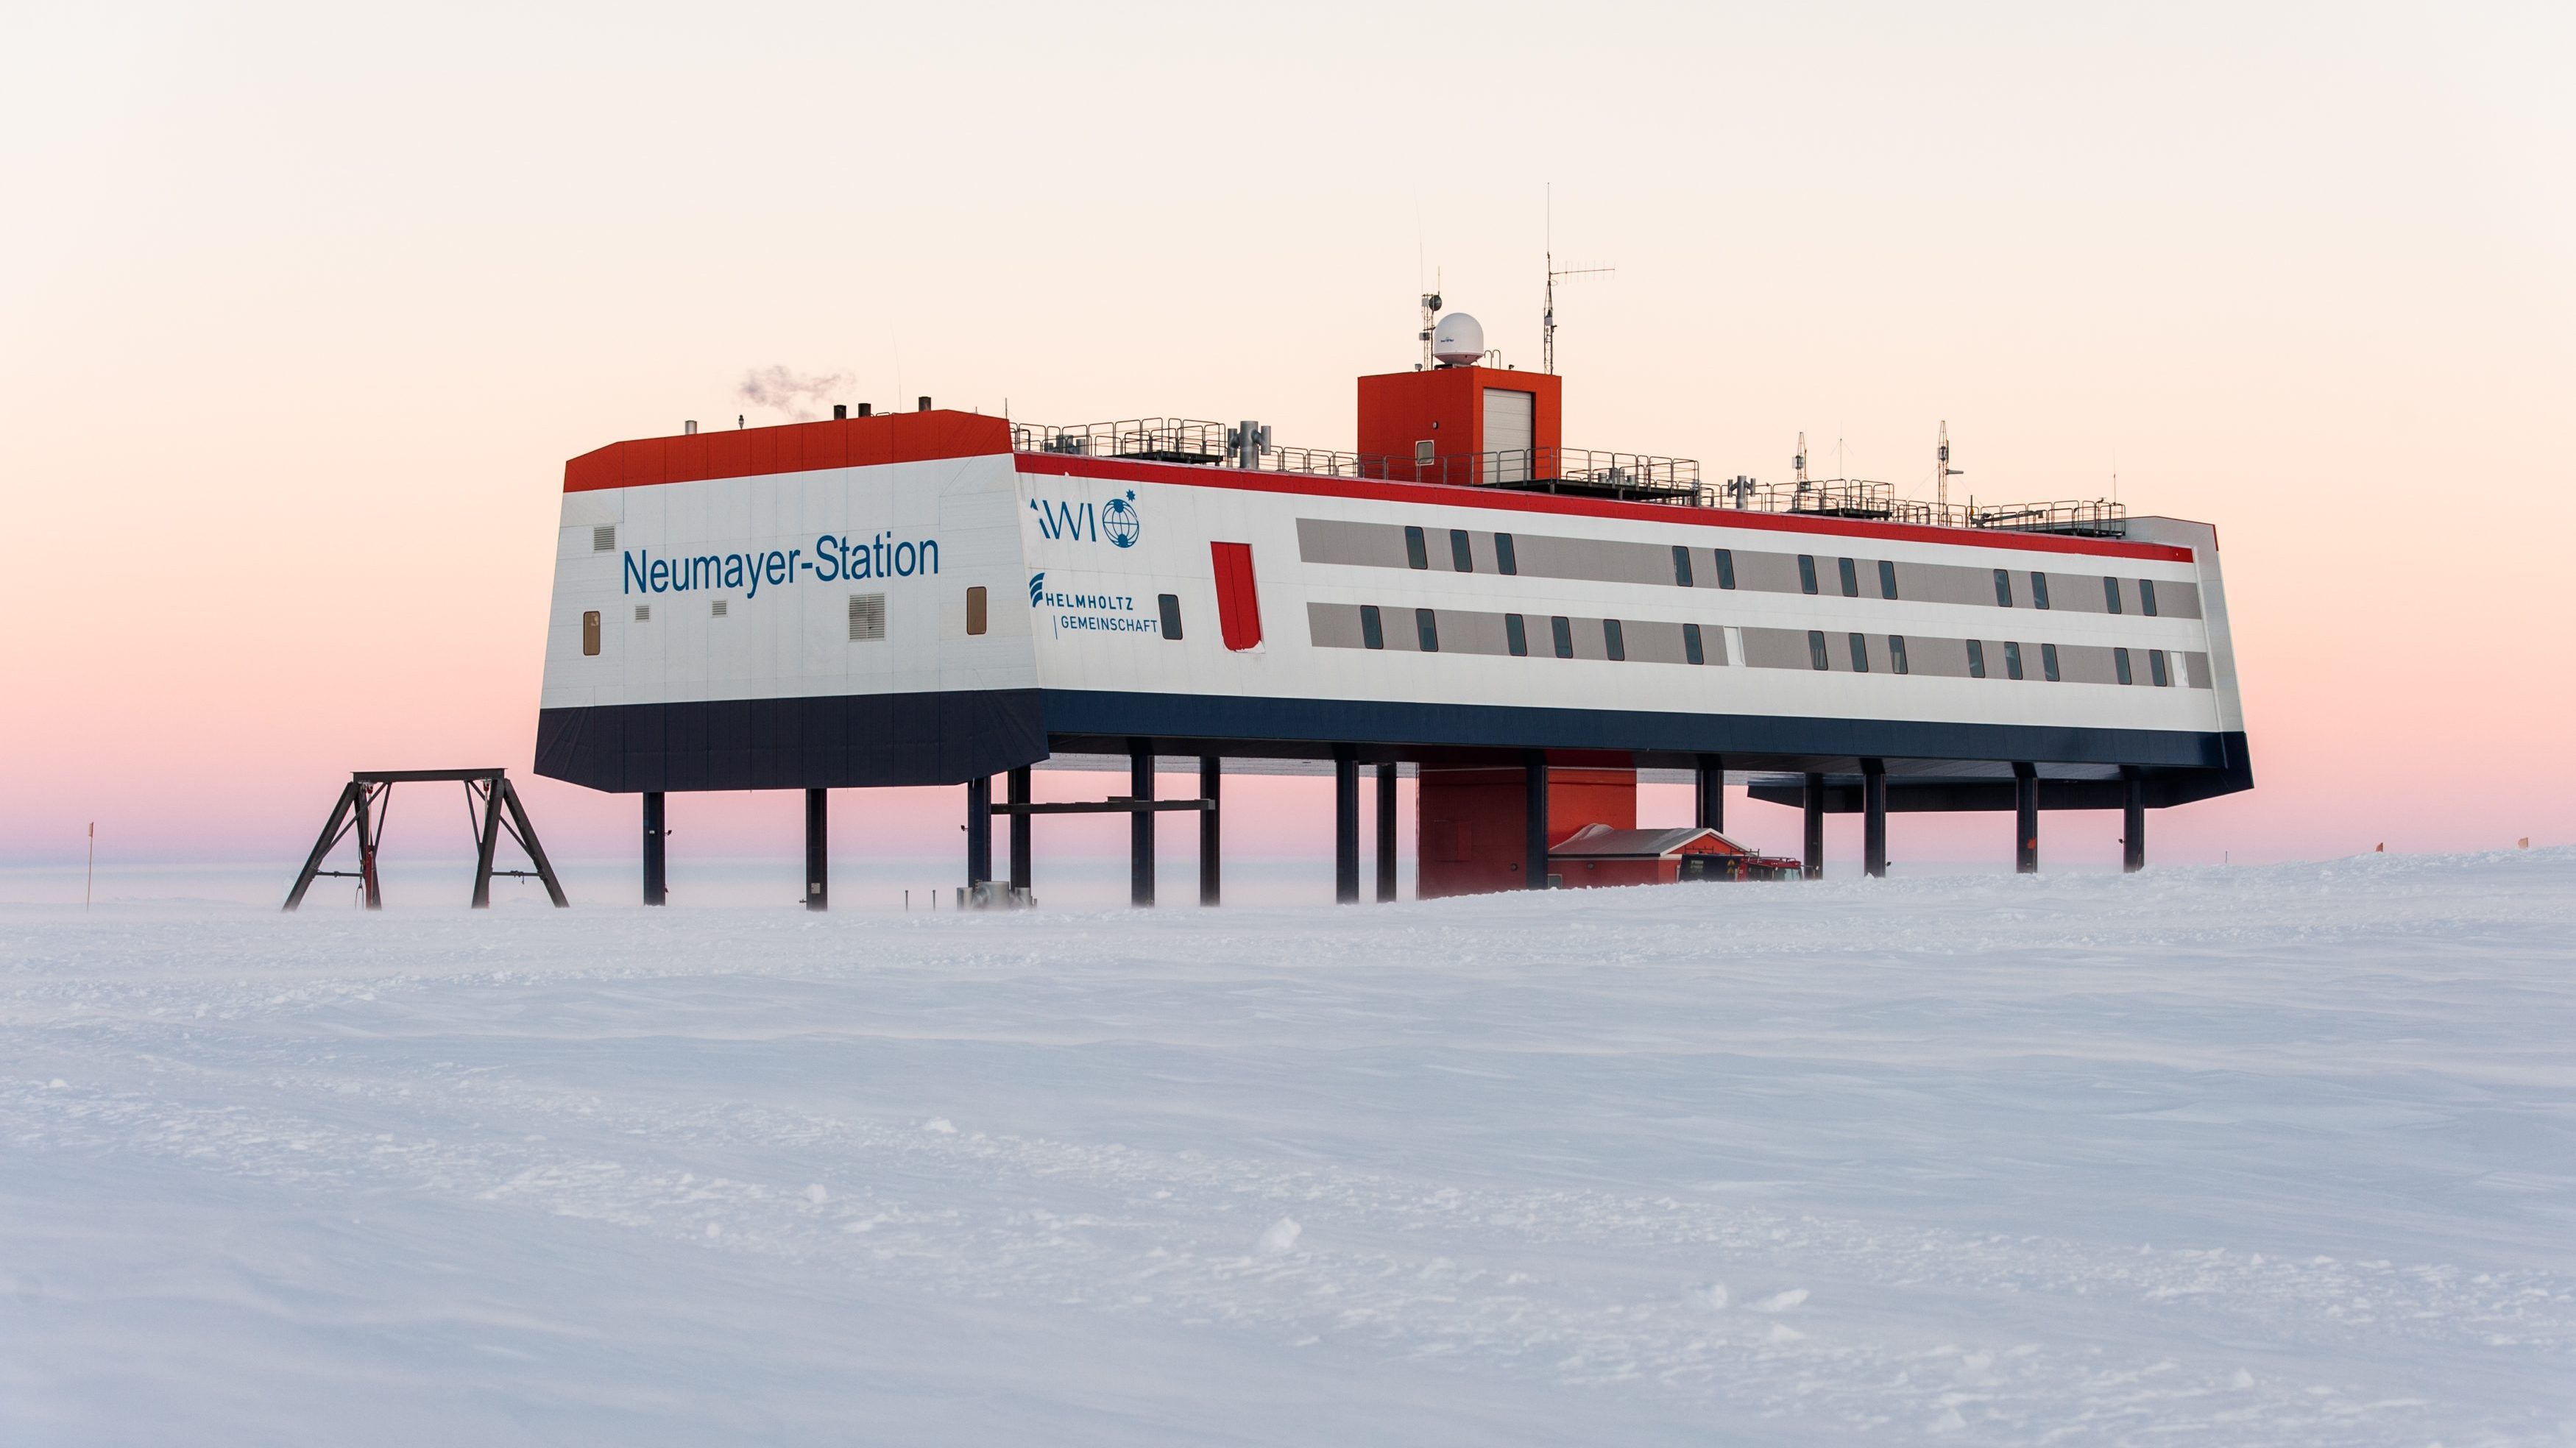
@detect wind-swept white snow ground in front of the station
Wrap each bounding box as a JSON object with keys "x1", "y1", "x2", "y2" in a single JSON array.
[{"x1": 0, "y1": 851, "x2": 2576, "y2": 1448}]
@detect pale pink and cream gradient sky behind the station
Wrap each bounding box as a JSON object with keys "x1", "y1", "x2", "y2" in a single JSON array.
[{"x1": 0, "y1": 3, "x2": 2576, "y2": 863}]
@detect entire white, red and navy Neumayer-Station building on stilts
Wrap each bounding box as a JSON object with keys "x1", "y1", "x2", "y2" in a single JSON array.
[{"x1": 539, "y1": 317, "x2": 2251, "y2": 909}]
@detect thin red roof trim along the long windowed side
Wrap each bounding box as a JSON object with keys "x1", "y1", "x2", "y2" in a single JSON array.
[{"x1": 1018, "y1": 453, "x2": 2193, "y2": 564}]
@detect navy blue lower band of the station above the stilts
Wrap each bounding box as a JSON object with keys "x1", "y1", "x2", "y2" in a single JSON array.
[{"x1": 536, "y1": 688, "x2": 2254, "y2": 809}]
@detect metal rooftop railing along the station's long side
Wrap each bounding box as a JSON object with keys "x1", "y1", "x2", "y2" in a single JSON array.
[{"x1": 1013, "y1": 417, "x2": 2128, "y2": 539}]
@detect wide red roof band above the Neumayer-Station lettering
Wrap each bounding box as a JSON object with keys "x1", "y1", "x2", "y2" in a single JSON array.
[{"x1": 565, "y1": 410, "x2": 1010, "y2": 492}]
